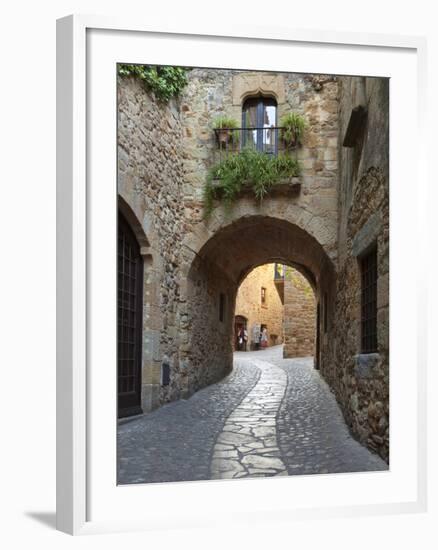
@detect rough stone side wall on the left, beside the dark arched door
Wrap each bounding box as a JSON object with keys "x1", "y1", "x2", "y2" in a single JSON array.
[{"x1": 118, "y1": 78, "x2": 184, "y2": 410}]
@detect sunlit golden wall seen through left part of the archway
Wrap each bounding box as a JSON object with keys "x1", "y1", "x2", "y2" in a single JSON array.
[{"x1": 235, "y1": 264, "x2": 283, "y2": 350}]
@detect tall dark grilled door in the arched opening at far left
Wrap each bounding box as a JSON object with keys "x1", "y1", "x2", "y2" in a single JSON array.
[{"x1": 117, "y1": 214, "x2": 143, "y2": 416}]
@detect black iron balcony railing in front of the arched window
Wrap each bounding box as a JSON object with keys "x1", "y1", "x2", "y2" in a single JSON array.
[{"x1": 214, "y1": 126, "x2": 286, "y2": 161}]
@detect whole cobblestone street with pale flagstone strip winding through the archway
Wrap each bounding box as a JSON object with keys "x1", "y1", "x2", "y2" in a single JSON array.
[{"x1": 118, "y1": 346, "x2": 388, "y2": 484}]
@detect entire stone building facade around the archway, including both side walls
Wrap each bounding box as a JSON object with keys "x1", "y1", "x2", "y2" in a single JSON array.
[{"x1": 118, "y1": 69, "x2": 388, "y2": 466}]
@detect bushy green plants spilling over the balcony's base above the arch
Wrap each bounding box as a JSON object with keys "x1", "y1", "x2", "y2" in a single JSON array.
[{"x1": 204, "y1": 148, "x2": 299, "y2": 217}]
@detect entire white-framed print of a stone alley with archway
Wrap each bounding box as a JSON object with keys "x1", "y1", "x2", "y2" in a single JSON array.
[{"x1": 57, "y1": 16, "x2": 426, "y2": 534}]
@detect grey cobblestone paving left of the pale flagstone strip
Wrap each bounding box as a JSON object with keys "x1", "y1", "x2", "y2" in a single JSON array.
[{"x1": 117, "y1": 360, "x2": 260, "y2": 483}]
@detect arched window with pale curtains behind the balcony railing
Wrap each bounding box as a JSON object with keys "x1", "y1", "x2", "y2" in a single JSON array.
[{"x1": 242, "y1": 96, "x2": 278, "y2": 155}]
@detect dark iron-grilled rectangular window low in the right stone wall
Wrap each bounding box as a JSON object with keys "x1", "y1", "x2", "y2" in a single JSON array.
[{"x1": 361, "y1": 248, "x2": 377, "y2": 353}]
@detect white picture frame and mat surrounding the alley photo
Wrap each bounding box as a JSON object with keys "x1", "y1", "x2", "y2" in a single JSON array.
[{"x1": 57, "y1": 16, "x2": 427, "y2": 534}]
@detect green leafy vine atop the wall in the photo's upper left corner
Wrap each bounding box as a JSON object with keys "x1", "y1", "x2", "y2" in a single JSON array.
[{"x1": 118, "y1": 63, "x2": 188, "y2": 101}]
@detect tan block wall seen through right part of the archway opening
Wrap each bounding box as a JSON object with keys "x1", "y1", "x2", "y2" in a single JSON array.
[{"x1": 283, "y1": 268, "x2": 316, "y2": 357}]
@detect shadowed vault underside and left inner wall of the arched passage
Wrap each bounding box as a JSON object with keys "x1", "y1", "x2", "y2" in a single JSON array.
[{"x1": 181, "y1": 215, "x2": 335, "y2": 394}]
